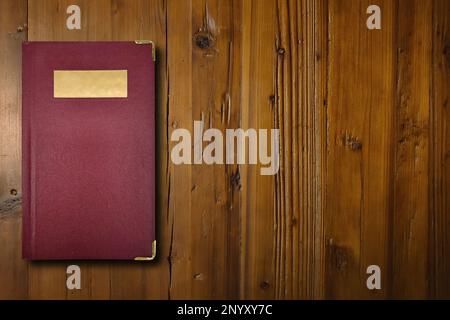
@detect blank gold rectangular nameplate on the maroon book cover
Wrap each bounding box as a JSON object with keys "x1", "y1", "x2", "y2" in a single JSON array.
[{"x1": 53, "y1": 70, "x2": 128, "y2": 98}]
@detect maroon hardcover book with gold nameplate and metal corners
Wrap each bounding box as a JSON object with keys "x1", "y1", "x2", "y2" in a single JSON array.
[{"x1": 22, "y1": 41, "x2": 156, "y2": 260}]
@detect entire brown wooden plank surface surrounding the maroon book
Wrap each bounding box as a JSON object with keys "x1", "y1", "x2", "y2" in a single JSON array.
[{"x1": 0, "y1": 0, "x2": 450, "y2": 299}]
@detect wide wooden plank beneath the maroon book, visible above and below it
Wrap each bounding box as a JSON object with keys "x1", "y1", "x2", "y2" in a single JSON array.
[{"x1": 29, "y1": 0, "x2": 169, "y2": 299}]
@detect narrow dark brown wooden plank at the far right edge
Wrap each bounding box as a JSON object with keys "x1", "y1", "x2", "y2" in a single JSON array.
[{"x1": 430, "y1": 0, "x2": 450, "y2": 299}]
